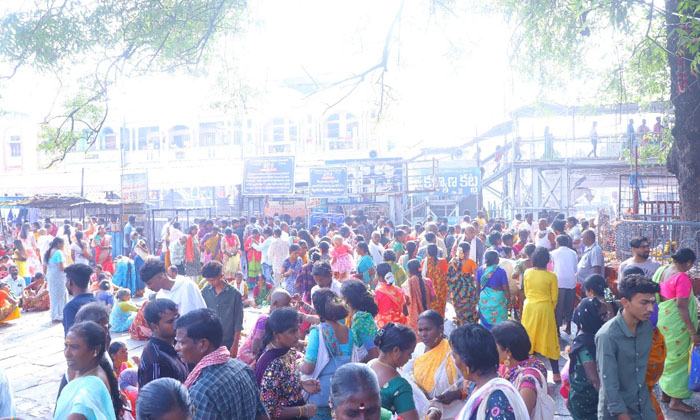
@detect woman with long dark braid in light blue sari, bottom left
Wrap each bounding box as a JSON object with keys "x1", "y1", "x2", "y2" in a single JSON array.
[{"x1": 54, "y1": 321, "x2": 122, "y2": 420}]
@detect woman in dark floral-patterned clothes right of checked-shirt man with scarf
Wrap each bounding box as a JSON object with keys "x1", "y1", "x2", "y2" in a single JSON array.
[{"x1": 255, "y1": 308, "x2": 320, "y2": 419}]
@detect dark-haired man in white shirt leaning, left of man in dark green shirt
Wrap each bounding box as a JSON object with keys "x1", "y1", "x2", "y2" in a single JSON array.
[{"x1": 140, "y1": 258, "x2": 207, "y2": 315}]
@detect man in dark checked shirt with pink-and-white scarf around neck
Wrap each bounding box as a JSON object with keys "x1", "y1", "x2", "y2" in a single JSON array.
[{"x1": 175, "y1": 306, "x2": 268, "y2": 420}]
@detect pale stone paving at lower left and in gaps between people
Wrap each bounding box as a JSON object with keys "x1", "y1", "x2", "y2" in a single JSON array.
[{"x1": 0, "y1": 302, "x2": 700, "y2": 420}]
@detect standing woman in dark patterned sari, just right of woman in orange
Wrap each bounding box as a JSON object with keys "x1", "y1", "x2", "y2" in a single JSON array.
[{"x1": 447, "y1": 242, "x2": 479, "y2": 326}]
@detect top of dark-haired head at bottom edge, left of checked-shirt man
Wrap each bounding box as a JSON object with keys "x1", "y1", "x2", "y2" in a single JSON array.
[{"x1": 136, "y1": 378, "x2": 194, "y2": 420}]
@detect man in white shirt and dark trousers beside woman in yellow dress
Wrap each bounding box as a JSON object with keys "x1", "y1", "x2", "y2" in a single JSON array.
[{"x1": 550, "y1": 235, "x2": 578, "y2": 335}]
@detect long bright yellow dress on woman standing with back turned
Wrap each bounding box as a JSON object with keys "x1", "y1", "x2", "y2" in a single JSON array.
[{"x1": 522, "y1": 268, "x2": 559, "y2": 360}]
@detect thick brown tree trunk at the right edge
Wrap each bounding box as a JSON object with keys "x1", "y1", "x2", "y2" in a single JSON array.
[{"x1": 666, "y1": 0, "x2": 700, "y2": 222}]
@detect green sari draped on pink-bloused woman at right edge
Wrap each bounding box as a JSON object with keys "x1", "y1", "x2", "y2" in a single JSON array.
[{"x1": 653, "y1": 265, "x2": 698, "y2": 399}]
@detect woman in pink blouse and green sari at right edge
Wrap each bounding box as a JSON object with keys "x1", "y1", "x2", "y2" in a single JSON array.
[{"x1": 654, "y1": 248, "x2": 700, "y2": 413}]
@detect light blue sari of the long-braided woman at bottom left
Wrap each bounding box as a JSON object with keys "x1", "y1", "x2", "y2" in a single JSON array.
[{"x1": 53, "y1": 375, "x2": 116, "y2": 420}]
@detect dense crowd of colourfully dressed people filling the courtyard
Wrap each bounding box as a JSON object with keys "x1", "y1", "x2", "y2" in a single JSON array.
[{"x1": 0, "y1": 211, "x2": 700, "y2": 420}]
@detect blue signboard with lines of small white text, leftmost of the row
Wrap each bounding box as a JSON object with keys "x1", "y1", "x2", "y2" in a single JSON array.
[{"x1": 242, "y1": 156, "x2": 294, "y2": 195}]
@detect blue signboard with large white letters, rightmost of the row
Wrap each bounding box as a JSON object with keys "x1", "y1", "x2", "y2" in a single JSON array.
[{"x1": 423, "y1": 161, "x2": 481, "y2": 196}]
